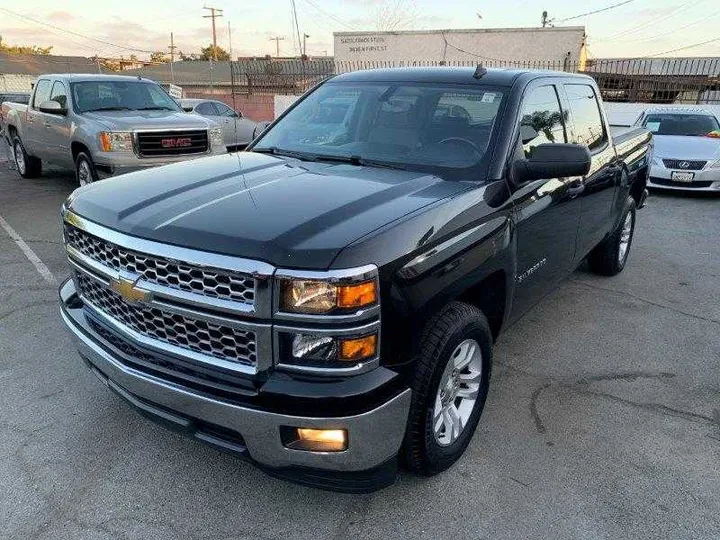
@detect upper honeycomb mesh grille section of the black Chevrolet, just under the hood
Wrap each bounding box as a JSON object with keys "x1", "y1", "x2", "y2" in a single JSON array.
[{"x1": 65, "y1": 224, "x2": 255, "y2": 305}]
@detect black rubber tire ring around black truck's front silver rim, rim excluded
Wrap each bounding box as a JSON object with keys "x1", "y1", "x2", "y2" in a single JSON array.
[{"x1": 424, "y1": 318, "x2": 492, "y2": 472}]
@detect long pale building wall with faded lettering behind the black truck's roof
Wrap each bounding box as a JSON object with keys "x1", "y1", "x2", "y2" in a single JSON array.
[{"x1": 334, "y1": 26, "x2": 585, "y2": 63}]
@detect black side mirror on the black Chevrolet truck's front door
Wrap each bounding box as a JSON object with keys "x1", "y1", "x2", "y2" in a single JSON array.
[{"x1": 514, "y1": 143, "x2": 591, "y2": 182}]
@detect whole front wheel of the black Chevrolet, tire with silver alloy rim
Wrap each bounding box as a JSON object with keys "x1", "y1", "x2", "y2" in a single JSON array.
[{"x1": 401, "y1": 302, "x2": 492, "y2": 476}]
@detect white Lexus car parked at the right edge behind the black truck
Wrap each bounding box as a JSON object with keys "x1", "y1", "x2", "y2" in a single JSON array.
[{"x1": 636, "y1": 108, "x2": 720, "y2": 192}]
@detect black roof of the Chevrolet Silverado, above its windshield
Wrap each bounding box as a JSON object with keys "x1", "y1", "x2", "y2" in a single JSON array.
[{"x1": 333, "y1": 67, "x2": 590, "y2": 86}]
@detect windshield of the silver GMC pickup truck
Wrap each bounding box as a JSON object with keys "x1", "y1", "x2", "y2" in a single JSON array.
[{"x1": 70, "y1": 81, "x2": 180, "y2": 113}]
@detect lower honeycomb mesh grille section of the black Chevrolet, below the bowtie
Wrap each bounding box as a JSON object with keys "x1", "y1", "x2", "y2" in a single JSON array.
[{"x1": 75, "y1": 272, "x2": 257, "y2": 365}]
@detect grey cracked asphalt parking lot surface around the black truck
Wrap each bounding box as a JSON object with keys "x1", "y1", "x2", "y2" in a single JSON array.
[{"x1": 0, "y1": 139, "x2": 720, "y2": 540}]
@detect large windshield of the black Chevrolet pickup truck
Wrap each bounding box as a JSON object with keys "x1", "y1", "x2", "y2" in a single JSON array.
[{"x1": 253, "y1": 82, "x2": 503, "y2": 174}]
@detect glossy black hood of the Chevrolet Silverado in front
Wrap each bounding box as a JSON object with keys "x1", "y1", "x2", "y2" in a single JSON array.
[{"x1": 70, "y1": 152, "x2": 468, "y2": 269}]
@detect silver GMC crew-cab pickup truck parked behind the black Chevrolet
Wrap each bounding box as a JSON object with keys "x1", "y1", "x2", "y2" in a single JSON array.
[{"x1": 2, "y1": 75, "x2": 226, "y2": 185}]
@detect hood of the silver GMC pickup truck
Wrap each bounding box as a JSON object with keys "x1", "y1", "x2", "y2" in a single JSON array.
[{"x1": 82, "y1": 111, "x2": 217, "y2": 131}]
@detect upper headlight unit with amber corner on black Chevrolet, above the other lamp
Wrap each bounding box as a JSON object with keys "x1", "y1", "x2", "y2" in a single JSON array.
[{"x1": 280, "y1": 279, "x2": 378, "y2": 315}]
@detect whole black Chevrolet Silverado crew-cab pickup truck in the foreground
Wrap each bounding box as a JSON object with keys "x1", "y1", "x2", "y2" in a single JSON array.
[{"x1": 60, "y1": 67, "x2": 650, "y2": 492}]
